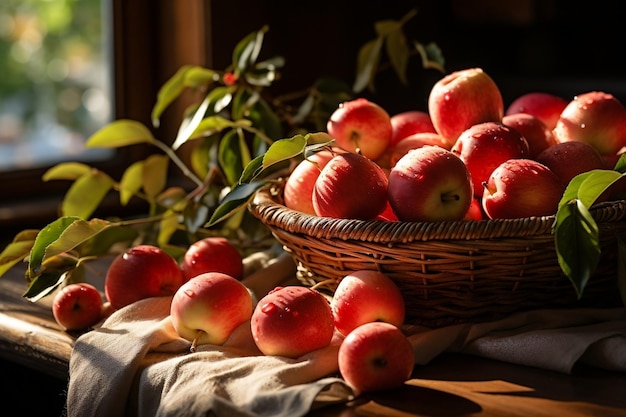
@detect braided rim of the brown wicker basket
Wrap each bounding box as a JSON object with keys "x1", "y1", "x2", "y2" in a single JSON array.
[{"x1": 248, "y1": 180, "x2": 626, "y2": 243}]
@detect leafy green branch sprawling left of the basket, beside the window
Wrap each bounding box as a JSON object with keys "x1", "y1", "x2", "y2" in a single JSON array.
[{"x1": 0, "y1": 10, "x2": 444, "y2": 301}]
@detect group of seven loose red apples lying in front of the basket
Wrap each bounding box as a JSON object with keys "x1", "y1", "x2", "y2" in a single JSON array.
[{"x1": 52, "y1": 237, "x2": 414, "y2": 394}]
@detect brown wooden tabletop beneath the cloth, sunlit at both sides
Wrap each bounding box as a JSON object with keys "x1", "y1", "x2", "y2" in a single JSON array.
[{"x1": 0, "y1": 264, "x2": 626, "y2": 417}]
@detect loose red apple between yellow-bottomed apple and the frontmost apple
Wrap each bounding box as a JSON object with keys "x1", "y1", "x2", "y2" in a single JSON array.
[{"x1": 251, "y1": 285, "x2": 335, "y2": 358}]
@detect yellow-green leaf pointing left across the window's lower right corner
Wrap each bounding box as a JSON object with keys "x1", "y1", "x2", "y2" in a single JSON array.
[{"x1": 85, "y1": 119, "x2": 155, "y2": 148}]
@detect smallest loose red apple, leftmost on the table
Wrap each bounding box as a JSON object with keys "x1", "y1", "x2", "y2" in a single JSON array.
[{"x1": 52, "y1": 282, "x2": 104, "y2": 331}]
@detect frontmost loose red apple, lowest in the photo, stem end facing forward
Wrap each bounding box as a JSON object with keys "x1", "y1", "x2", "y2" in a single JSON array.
[{"x1": 337, "y1": 322, "x2": 415, "y2": 396}]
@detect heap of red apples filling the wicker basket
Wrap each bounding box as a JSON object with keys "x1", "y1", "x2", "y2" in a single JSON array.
[{"x1": 284, "y1": 68, "x2": 626, "y2": 222}]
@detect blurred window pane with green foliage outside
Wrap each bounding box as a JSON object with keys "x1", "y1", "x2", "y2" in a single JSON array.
[{"x1": 0, "y1": 0, "x2": 113, "y2": 171}]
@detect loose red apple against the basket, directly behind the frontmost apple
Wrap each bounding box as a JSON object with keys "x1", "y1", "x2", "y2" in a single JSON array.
[{"x1": 330, "y1": 269, "x2": 405, "y2": 336}]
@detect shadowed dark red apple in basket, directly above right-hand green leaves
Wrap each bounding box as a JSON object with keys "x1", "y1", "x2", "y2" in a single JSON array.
[{"x1": 535, "y1": 141, "x2": 606, "y2": 185}]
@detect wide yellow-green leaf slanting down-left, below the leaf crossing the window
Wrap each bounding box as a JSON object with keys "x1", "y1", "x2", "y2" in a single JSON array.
[{"x1": 61, "y1": 170, "x2": 115, "y2": 219}]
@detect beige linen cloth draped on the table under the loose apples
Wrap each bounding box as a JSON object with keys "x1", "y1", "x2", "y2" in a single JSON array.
[{"x1": 67, "y1": 247, "x2": 626, "y2": 417}]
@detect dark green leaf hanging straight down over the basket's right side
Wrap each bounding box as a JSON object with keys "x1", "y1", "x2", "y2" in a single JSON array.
[{"x1": 554, "y1": 200, "x2": 600, "y2": 298}]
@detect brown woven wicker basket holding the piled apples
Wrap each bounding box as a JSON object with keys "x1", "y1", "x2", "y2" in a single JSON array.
[{"x1": 249, "y1": 183, "x2": 626, "y2": 327}]
